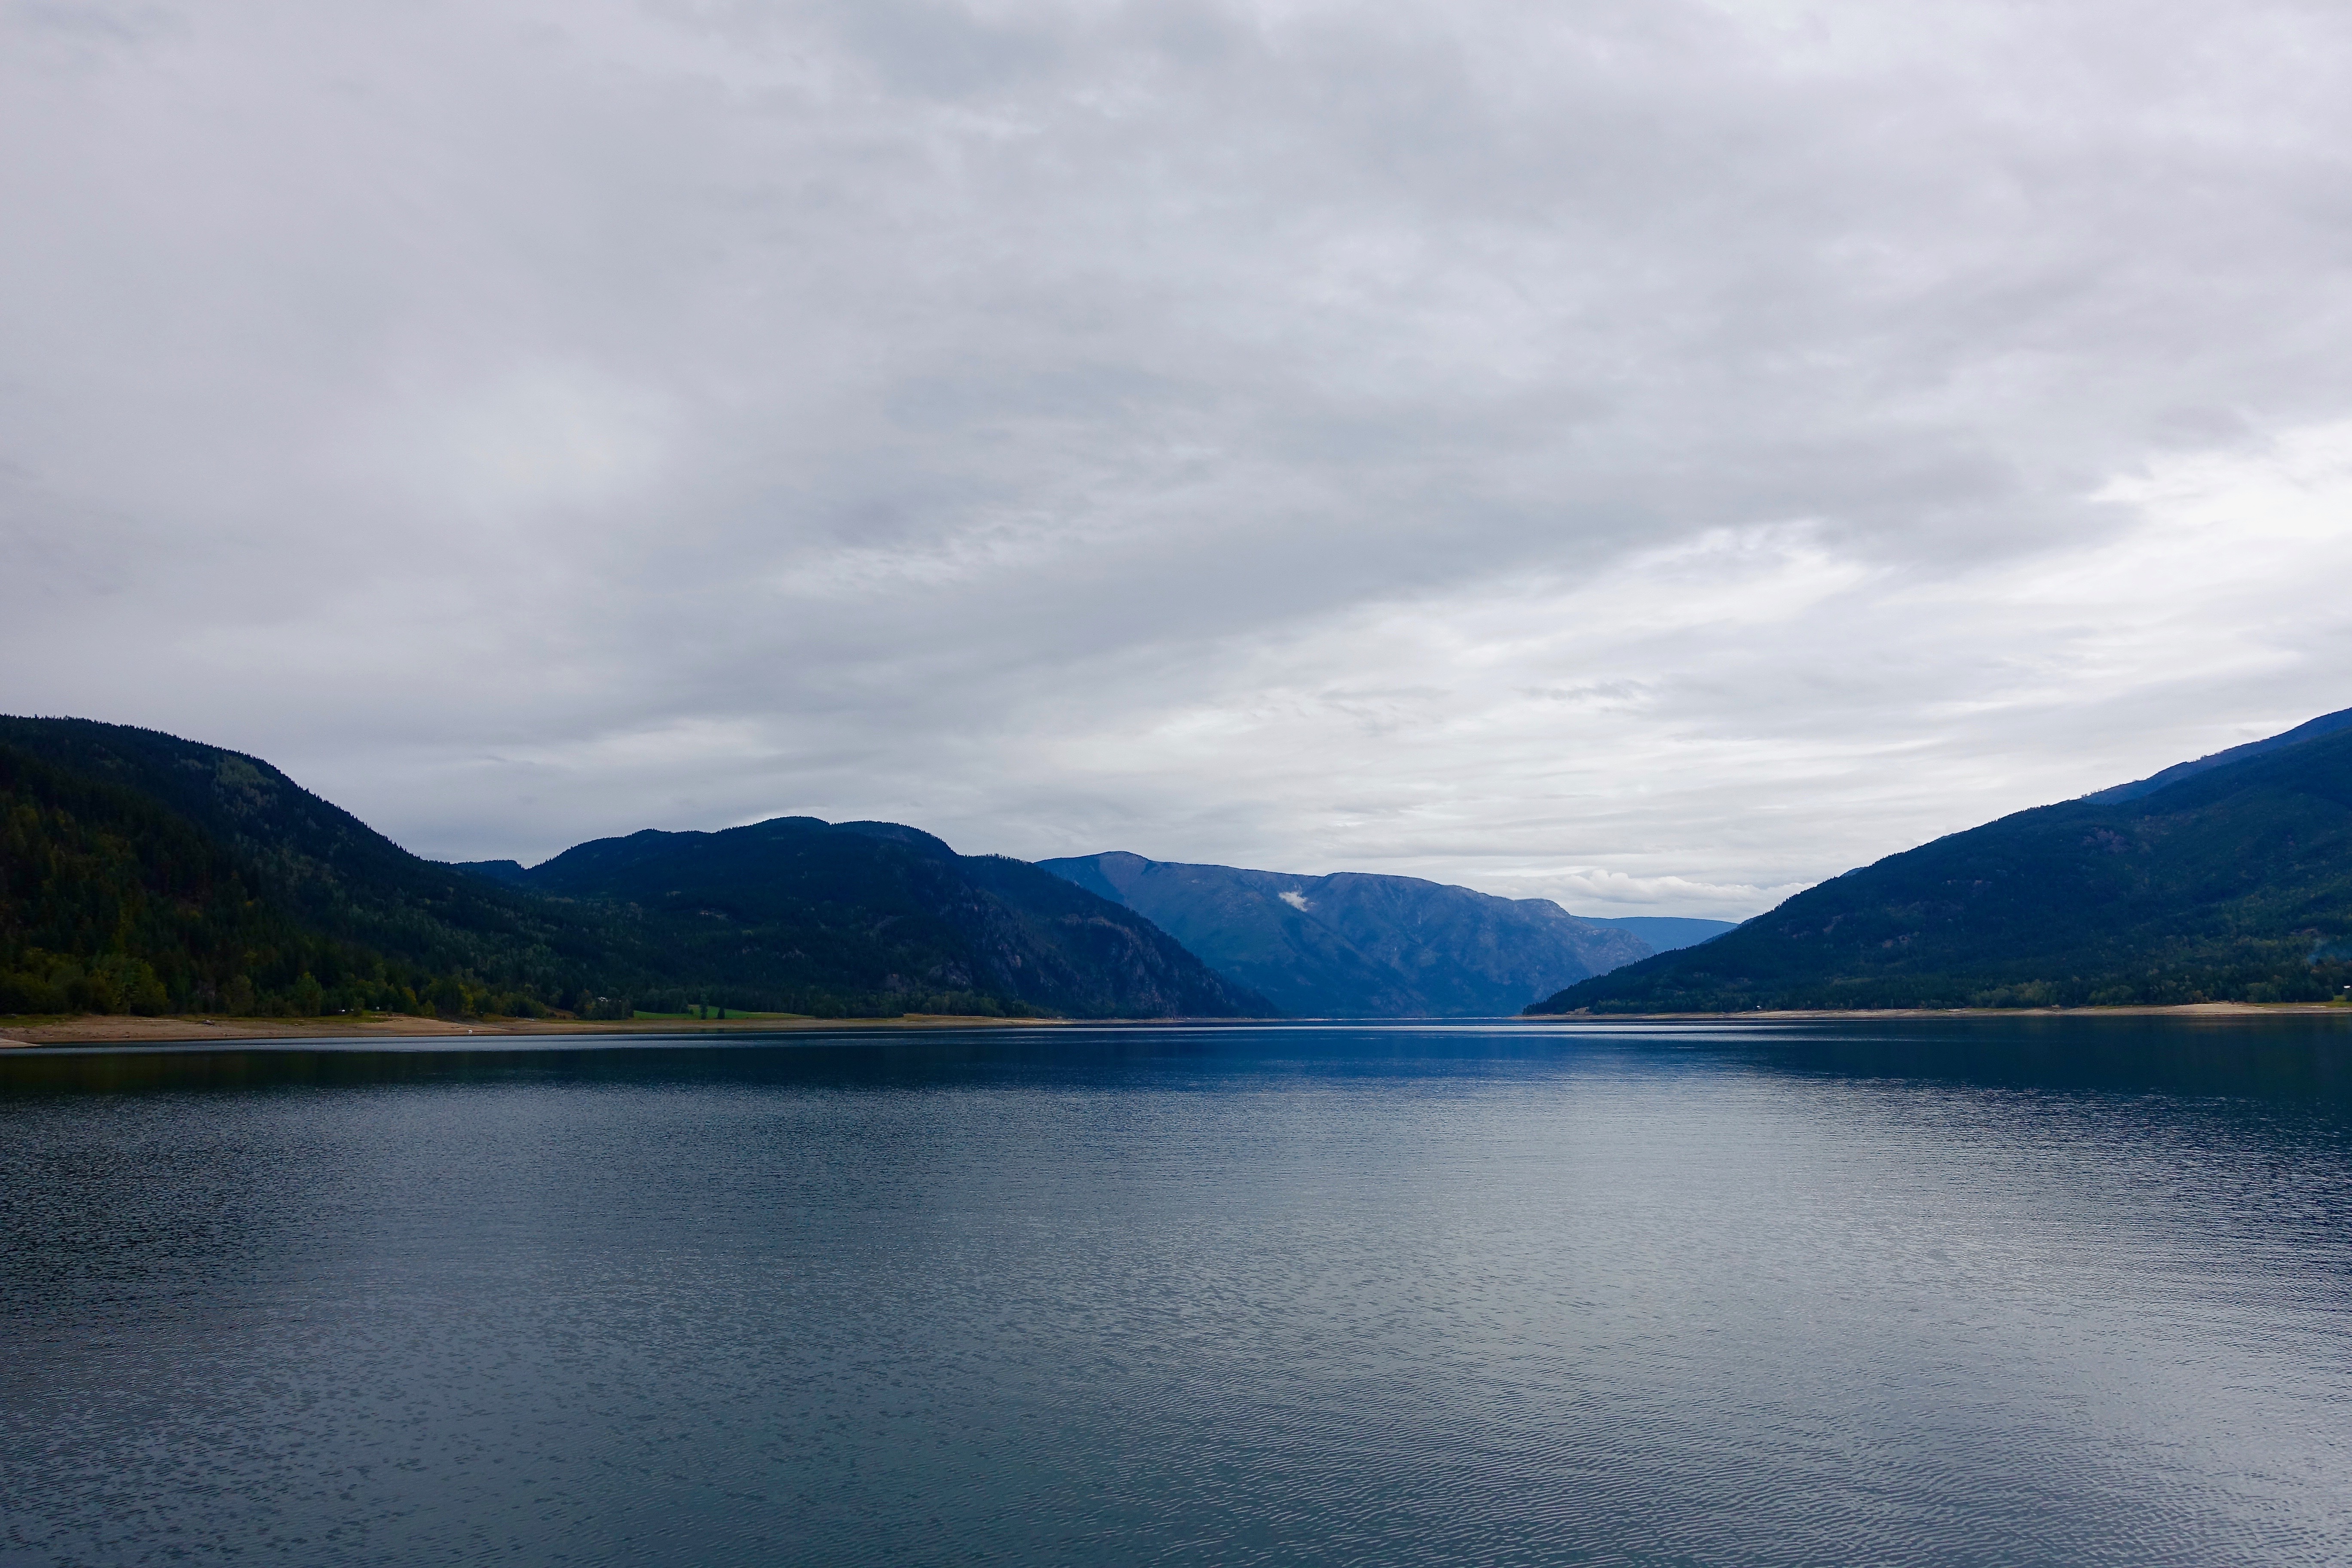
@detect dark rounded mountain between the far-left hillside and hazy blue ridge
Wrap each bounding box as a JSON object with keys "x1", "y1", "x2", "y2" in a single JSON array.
[{"x1": 478, "y1": 816, "x2": 1272, "y2": 1018}]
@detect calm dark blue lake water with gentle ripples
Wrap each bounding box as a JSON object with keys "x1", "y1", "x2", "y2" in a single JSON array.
[{"x1": 0, "y1": 1018, "x2": 2352, "y2": 1568}]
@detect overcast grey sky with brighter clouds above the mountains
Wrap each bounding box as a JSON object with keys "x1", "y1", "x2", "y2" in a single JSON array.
[{"x1": 0, "y1": 0, "x2": 2352, "y2": 917}]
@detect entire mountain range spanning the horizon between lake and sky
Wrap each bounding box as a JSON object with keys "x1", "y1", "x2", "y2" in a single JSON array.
[{"x1": 0, "y1": 710, "x2": 2352, "y2": 1034}]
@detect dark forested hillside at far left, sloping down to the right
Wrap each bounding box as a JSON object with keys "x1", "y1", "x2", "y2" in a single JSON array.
[{"x1": 0, "y1": 717, "x2": 614, "y2": 1013}]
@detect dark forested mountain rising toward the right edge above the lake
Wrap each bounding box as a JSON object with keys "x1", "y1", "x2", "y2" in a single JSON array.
[{"x1": 1529, "y1": 715, "x2": 2352, "y2": 1013}]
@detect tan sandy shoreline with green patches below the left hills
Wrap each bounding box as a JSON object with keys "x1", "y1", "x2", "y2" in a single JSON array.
[{"x1": 0, "y1": 1013, "x2": 1063, "y2": 1046}]
